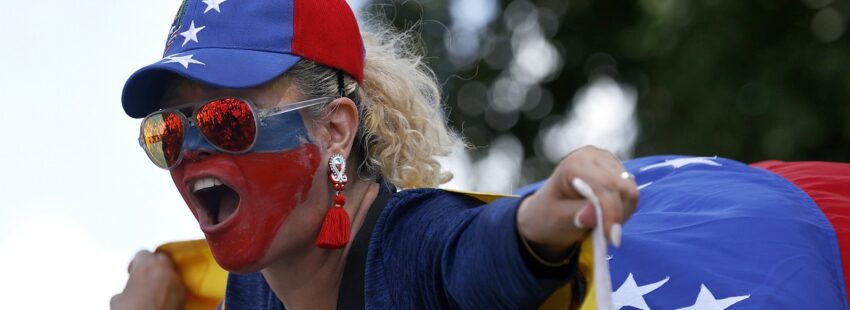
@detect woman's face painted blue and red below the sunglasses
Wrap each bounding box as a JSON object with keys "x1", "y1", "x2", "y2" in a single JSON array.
[{"x1": 163, "y1": 81, "x2": 321, "y2": 271}]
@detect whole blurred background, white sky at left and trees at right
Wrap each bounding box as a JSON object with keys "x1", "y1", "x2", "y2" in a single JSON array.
[{"x1": 0, "y1": 0, "x2": 850, "y2": 309}]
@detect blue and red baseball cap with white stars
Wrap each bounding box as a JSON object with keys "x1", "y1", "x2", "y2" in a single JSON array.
[{"x1": 121, "y1": 0, "x2": 364, "y2": 118}]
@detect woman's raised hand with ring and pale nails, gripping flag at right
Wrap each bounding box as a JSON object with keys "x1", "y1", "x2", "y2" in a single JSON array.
[{"x1": 517, "y1": 146, "x2": 639, "y2": 261}]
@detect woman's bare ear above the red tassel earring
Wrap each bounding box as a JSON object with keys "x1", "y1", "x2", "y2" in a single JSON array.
[{"x1": 323, "y1": 97, "x2": 360, "y2": 158}]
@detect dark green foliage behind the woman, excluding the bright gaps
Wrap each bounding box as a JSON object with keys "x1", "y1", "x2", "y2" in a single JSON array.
[{"x1": 364, "y1": 0, "x2": 850, "y2": 177}]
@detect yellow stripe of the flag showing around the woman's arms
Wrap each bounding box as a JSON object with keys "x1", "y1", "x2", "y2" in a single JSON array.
[{"x1": 161, "y1": 190, "x2": 596, "y2": 310}]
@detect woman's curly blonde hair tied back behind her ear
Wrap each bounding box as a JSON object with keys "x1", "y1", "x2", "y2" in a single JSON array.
[{"x1": 286, "y1": 23, "x2": 465, "y2": 188}]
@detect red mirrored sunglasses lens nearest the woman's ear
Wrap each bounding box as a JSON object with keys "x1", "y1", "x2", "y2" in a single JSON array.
[{"x1": 195, "y1": 98, "x2": 257, "y2": 152}]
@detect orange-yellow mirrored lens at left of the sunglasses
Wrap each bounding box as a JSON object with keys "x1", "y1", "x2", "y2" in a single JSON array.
[{"x1": 142, "y1": 112, "x2": 183, "y2": 168}]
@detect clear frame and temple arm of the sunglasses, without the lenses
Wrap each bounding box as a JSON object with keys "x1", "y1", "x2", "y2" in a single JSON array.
[{"x1": 139, "y1": 96, "x2": 336, "y2": 170}]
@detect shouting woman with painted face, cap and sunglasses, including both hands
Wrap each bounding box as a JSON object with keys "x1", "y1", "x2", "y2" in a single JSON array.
[{"x1": 112, "y1": 0, "x2": 638, "y2": 309}]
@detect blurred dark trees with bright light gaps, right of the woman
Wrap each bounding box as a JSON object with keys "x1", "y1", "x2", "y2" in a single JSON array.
[{"x1": 374, "y1": 0, "x2": 850, "y2": 192}]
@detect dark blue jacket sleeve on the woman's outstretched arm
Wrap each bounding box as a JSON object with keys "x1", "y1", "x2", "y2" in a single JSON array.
[{"x1": 367, "y1": 190, "x2": 577, "y2": 309}]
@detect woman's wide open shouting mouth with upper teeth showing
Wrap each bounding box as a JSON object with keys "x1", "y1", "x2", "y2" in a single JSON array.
[{"x1": 191, "y1": 177, "x2": 239, "y2": 226}]
